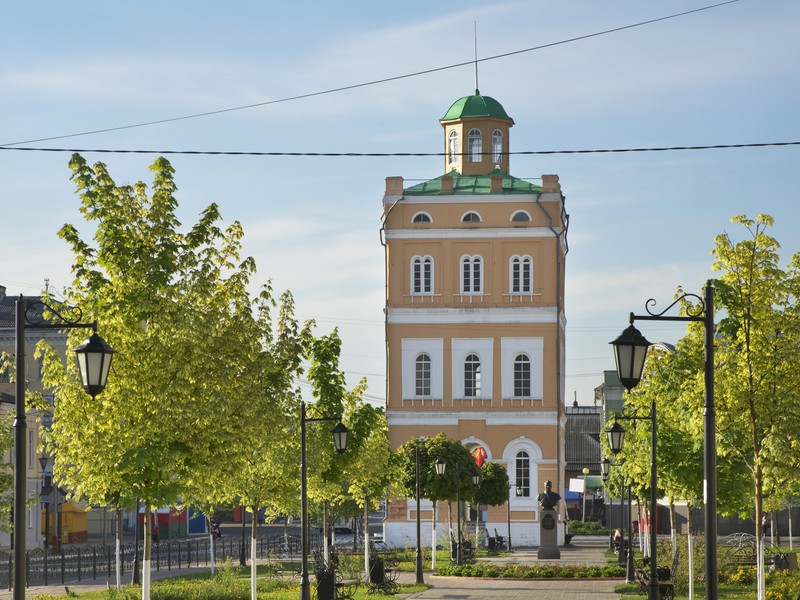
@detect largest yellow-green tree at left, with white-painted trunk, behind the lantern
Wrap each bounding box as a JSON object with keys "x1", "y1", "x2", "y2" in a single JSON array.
[{"x1": 43, "y1": 154, "x2": 260, "y2": 599}]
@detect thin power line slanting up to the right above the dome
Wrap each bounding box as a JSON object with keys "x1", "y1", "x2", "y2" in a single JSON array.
[{"x1": 0, "y1": 0, "x2": 739, "y2": 148}]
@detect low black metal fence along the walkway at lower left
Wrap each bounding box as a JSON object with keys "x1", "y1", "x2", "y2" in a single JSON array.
[{"x1": 0, "y1": 534, "x2": 322, "y2": 590}]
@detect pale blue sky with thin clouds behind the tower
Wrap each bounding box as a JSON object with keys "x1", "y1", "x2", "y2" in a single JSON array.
[{"x1": 0, "y1": 0, "x2": 800, "y2": 404}]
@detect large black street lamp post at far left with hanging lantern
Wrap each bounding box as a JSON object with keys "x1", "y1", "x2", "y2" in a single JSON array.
[{"x1": 13, "y1": 294, "x2": 114, "y2": 600}]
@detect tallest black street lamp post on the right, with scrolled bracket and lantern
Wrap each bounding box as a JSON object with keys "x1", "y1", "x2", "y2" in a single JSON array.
[{"x1": 612, "y1": 280, "x2": 718, "y2": 600}]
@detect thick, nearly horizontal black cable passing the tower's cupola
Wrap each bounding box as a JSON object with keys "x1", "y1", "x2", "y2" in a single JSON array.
[{"x1": 0, "y1": 141, "x2": 800, "y2": 158}]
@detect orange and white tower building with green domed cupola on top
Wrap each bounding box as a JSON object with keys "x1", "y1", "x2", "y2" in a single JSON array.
[{"x1": 382, "y1": 90, "x2": 568, "y2": 545}]
